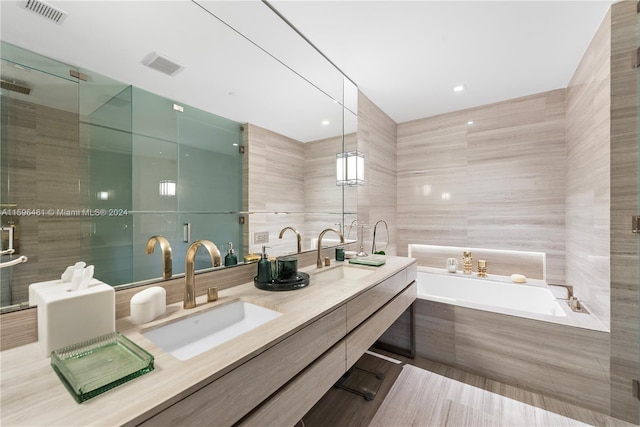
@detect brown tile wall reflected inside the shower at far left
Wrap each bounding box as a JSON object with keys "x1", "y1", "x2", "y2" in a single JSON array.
[{"x1": 1, "y1": 96, "x2": 88, "y2": 305}]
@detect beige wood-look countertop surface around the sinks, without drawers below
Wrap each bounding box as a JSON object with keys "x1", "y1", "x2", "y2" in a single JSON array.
[{"x1": 0, "y1": 256, "x2": 415, "y2": 427}]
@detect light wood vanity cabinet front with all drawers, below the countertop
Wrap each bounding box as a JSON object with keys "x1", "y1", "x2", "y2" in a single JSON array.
[{"x1": 141, "y1": 264, "x2": 416, "y2": 427}]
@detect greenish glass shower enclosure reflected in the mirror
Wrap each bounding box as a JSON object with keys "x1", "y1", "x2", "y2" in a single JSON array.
[{"x1": 0, "y1": 43, "x2": 243, "y2": 310}]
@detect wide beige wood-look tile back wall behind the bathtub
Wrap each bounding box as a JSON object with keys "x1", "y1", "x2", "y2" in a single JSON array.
[{"x1": 397, "y1": 89, "x2": 566, "y2": 283}]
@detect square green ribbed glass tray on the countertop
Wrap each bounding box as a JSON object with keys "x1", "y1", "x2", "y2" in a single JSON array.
[{"x1": 51, "y1": 332, "x2": 154, "y2": 403}]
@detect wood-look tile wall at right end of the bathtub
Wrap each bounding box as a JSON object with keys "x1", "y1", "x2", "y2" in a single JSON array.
[{"x1": 566, "y1": 7, "x2": 611, "y2": 332}]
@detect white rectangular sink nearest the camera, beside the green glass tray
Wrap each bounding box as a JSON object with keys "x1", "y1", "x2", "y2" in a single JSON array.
[{"x1": 142, "y1": 301, "x2": 281, "y2": 360}]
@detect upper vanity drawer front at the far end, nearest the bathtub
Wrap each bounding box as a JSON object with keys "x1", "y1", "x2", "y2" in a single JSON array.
[{"x1": 347, "y1": 268, "x2": 410, "y2": 332}]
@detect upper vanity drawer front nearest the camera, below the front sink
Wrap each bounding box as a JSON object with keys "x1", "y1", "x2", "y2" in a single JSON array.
[{"x1": 141, "y1": 306, "x2": 346, "y2": 427}]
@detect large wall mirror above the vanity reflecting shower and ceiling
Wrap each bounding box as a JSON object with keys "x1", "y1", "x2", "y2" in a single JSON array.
[{"x1": 0, "y1": 1, "x2": 357, "y2": 311}]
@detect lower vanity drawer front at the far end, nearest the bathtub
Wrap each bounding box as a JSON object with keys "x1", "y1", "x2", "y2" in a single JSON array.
[{"x1": 346, "y1": 282, "x2": 418, "y2": 369}]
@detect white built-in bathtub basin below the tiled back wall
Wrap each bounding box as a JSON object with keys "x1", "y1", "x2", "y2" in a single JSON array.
[{"x1": 417, "y1": 267, "x2": 567, "y2": 318}]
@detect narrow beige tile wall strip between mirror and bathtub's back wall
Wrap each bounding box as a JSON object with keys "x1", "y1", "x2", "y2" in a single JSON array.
[{"x1": 358, "y1": 92, "x2": 398, "y2": 255}]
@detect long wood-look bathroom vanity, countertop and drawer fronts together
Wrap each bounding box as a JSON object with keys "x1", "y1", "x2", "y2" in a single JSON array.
[{"x1": 1, "y1": 257, "x2": 416, "y2": 426}]
